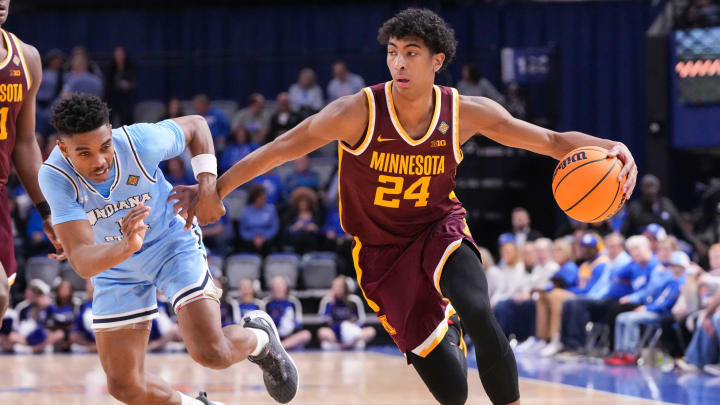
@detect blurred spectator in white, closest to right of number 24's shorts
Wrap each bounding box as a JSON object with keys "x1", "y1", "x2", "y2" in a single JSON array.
[{"x1": 487, "y1": 233, "x2": 527, "y2": 307}]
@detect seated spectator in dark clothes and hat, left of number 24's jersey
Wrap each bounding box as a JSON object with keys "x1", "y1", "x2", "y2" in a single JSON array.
[{"x1": 285, "y1": 187, "x2": 320, "y2": 255}]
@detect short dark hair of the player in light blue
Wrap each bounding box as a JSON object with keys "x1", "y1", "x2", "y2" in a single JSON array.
[{"x1": 50, "y1": 93, "x2": 110, "y2": 136}]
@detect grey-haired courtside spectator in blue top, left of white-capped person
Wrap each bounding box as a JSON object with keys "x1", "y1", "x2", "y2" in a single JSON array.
[{"x1": 546, "y1": 235, "x2": 662, "y2": 355}]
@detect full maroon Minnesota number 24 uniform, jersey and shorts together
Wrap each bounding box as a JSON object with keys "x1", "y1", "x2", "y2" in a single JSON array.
[{"x1": 338, "y1": 82, "x2": 474, "y2": 357}]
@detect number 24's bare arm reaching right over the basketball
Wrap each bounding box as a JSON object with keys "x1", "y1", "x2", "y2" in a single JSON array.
[{"x1": 460, "y1": 96, "x2": 638, "y2": 198}]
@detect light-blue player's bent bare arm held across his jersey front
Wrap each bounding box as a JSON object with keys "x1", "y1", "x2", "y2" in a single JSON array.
[{"x1": 55, "y1": 204, "x2": 150, "y2": 278}]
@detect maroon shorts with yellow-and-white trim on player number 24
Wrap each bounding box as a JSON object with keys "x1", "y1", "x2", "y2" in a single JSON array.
[{"x1": 352, "y1": 215, "x2": 474, "y2": 357}]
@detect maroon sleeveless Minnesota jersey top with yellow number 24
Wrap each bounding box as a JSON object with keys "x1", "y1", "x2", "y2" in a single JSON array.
[{"x1": 339, "y1": 82, "x2": 465, "y2": 245}]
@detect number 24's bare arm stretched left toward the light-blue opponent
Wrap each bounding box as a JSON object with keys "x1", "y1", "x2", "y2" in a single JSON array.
[{"x1": 170, "y1": 91, "x2": 368, "y2": 227}]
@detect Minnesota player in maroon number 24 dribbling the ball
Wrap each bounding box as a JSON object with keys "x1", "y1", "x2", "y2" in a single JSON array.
[{"x1": 171, "y1": 9, "x2": 637, "y2": 405}]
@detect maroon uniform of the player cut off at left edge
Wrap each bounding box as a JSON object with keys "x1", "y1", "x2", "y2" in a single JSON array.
[{"x1": 0, "y1": 29, "x2": 32, "y2": 283}]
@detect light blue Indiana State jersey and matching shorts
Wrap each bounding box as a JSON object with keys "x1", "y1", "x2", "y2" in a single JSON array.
[{"x1": 38, "y1": 120, "x2": 214, "y2": 329}]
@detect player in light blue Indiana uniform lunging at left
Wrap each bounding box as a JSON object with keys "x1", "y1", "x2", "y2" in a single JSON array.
[{"x1": 38, "y1": 95, "x2": 298, "y2": 405}]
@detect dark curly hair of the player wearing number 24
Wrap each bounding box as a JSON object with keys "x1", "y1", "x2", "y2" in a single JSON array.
[{"x1": 378, "y1": 8, "x2": 457, "y2": 70}]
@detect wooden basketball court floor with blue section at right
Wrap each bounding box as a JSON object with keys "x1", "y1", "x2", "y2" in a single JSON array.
[{"x1": 0, "y1": 348, "x2": 720, "y2": 405}]
